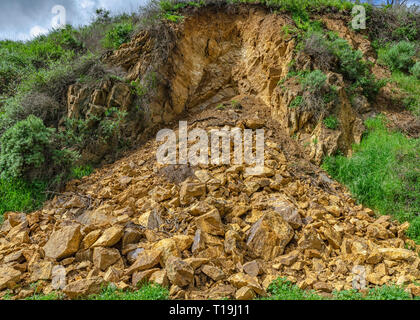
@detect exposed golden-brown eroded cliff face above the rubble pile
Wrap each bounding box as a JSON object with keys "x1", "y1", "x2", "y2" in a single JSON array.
[{"x1": 101, "y1": 7, "x2": 380, "y2": 164}]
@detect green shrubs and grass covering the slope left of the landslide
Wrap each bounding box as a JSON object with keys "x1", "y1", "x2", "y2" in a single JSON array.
[{"x1": 0, "y1": 9, "x2": 151, "y2": 215}]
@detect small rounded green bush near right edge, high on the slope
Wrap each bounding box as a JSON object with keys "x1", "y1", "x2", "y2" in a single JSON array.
[{"x1": 378, "y1": 41, "x2": 416, "y2": 71}]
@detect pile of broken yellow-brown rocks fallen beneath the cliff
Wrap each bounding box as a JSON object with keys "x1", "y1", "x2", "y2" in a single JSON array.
[{"x1": 0, "y1": 97, "x2": 420, "y2": 299}]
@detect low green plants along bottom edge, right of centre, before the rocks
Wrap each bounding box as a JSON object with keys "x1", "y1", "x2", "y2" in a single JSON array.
[{"x1": 261, "y1": 278, "x2": 419, "y2": 300}]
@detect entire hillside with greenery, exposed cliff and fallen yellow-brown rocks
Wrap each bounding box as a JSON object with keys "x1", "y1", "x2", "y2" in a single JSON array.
[{"x1": 0, "y1": 1, "x2": 420, "y2": 299}]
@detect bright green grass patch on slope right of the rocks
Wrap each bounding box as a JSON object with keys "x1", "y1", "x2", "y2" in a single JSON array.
[{"x1": 323, "y1": 117, "x2": 420, "y2": 242}]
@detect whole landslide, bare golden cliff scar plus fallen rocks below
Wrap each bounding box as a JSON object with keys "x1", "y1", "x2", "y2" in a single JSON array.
[{"x1": 0, "y1": 6, "x2": 420, "y2": 299}]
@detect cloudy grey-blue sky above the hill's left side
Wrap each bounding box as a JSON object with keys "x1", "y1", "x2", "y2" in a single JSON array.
[{"x1": 0, "y1": 0, "x2": 146, "y2": 40}]
